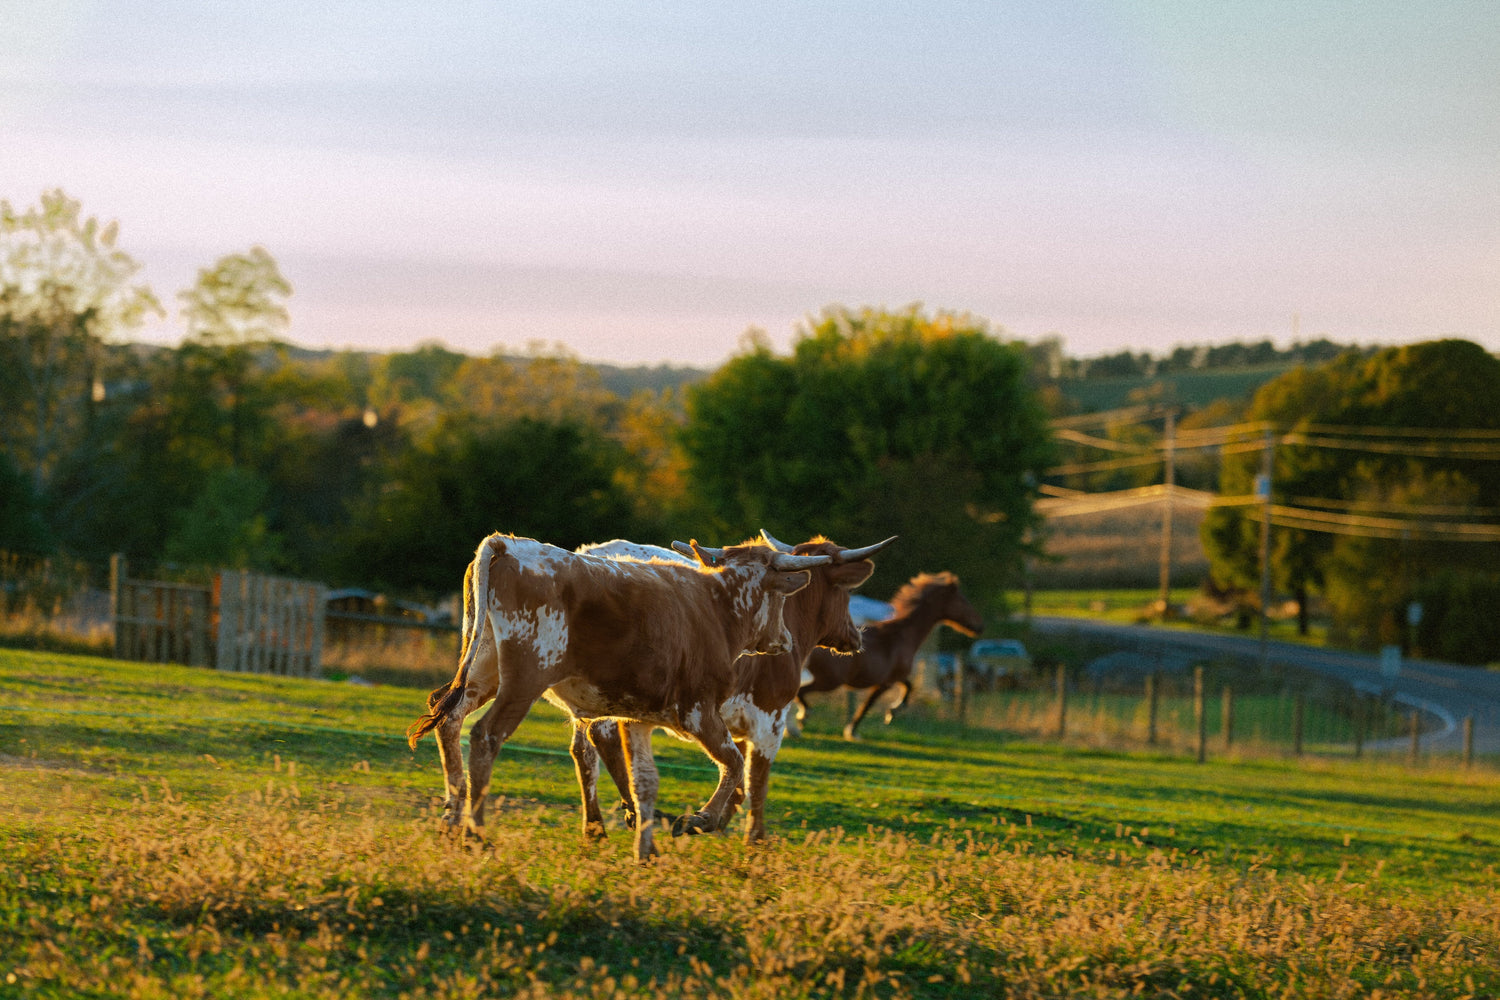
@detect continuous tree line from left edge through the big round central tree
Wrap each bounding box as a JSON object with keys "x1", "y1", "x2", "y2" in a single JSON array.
[{"x1": 0, "y1": 192, "x2": 1052, "y2": 611}]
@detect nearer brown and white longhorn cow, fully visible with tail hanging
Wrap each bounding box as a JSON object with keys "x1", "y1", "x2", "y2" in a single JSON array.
[{"x1": 407, "y1": 534, "x2": 833, "y2": 861}]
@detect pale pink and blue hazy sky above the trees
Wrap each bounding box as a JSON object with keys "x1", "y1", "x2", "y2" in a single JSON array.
[{"x1": 0, "y1": 0, "x2": 1500, "y2": 367}]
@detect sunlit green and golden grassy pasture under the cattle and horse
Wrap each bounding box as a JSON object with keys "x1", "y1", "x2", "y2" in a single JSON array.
[{"x1": 0, "y1": 651, "x2": 1500, "y2": 999}]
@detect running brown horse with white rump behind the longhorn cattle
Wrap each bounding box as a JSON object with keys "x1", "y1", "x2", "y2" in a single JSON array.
[{"x1": 797, "y1": 573, "x2": 984, "y2": 739}]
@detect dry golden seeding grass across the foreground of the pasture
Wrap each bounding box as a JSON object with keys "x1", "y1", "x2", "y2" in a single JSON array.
[{"x1": 0, "y1": 769, "x2": 1500, "y2": 1000}]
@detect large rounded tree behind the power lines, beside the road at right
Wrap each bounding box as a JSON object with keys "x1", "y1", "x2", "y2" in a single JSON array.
[{"x1": 1203, "y1": 340, "x2": 1500, "y2": 643}]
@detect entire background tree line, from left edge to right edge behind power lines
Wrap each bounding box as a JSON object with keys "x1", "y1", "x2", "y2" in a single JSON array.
[{"x1": 0, "y1": 192, "x2": 1500, "y2": 660}]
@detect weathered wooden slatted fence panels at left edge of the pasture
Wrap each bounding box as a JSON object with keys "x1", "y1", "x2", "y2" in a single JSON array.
[{"x1": 110, "y1": 555, "x2": 327, "y2": 676}]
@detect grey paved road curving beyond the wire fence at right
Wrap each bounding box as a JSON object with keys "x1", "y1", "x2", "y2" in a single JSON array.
[{"x1": 1032, "y1": 616, "x2": 1500, "y2": 754}]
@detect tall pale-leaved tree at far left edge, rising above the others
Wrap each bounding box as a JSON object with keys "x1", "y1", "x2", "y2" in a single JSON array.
[{"x1": 0, "y1": 190, "x2": 161, "y2": 496}]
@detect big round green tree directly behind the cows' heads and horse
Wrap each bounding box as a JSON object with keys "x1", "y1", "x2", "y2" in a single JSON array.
[{"x1": 683, "y1": 307, "x2": 1053, "y2": 600}]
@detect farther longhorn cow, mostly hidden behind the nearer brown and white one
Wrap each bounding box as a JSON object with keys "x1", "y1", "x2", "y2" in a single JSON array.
[{"x1": 572, "y1": 532, "x2": 896, "y2": 843}]
